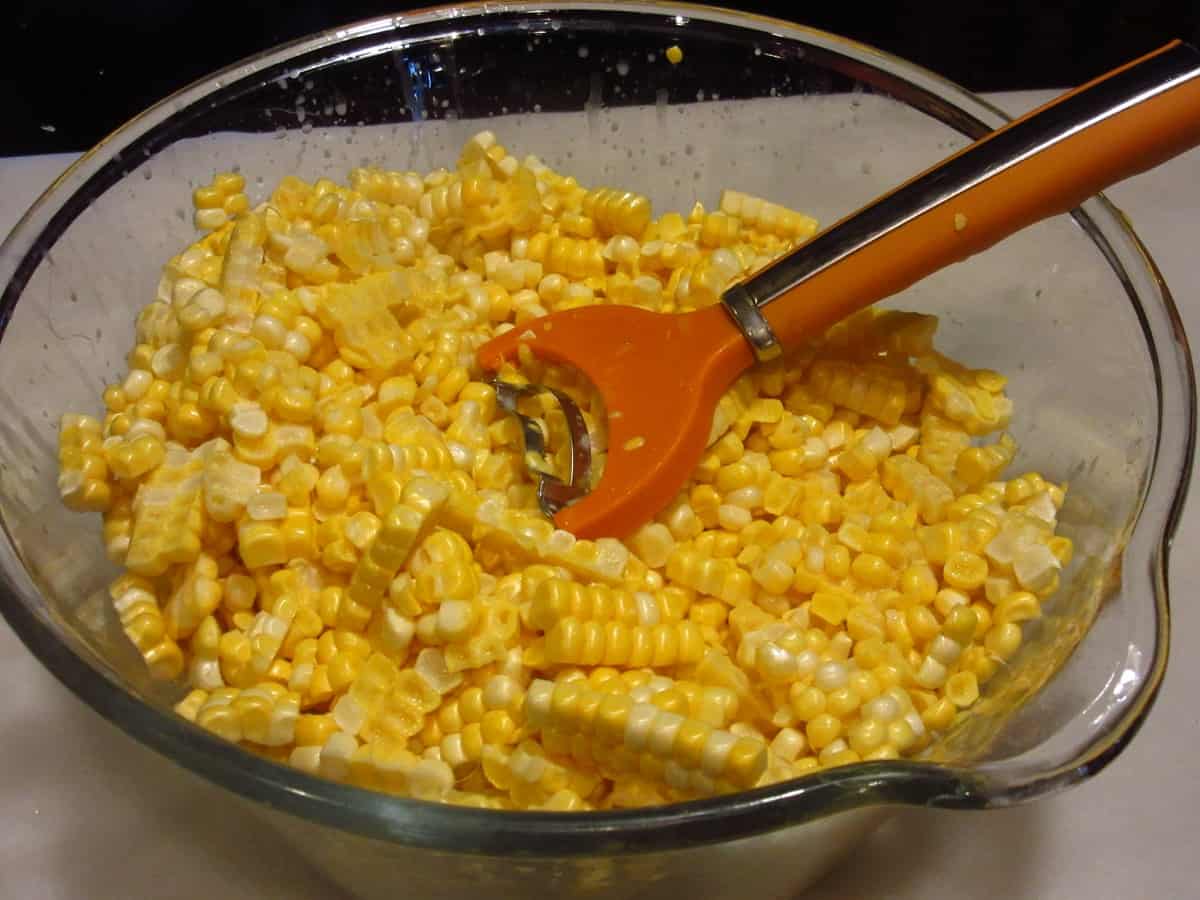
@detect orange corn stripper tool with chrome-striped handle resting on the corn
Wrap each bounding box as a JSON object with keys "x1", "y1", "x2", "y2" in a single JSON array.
[{"x1": 478, "y1": 41, "x2": 1200, "y2": 538}]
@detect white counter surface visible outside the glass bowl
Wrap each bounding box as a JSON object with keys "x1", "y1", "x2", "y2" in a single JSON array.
[{"x1": 0, "y1": 92, "x2": 1200, "y2": 900}]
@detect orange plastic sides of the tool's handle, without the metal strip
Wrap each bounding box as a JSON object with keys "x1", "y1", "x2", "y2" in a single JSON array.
[{"x1": 762, "y1": 41, "x2": 1200, "y2": 347}]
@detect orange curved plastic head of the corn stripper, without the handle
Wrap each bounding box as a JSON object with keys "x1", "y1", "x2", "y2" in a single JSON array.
[{"x1": 478, "y1": 305, "x2": 754, "y2": 538}]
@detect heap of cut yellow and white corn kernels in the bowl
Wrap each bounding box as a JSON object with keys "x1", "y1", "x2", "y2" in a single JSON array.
[{"x1": 59, "y1": 132, "x2": 1072, "y2": 810}]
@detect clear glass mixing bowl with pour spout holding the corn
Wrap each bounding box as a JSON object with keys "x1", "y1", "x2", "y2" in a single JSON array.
[{"x1": 0, "y1": 2, "x2": 1195, "y2": 898}]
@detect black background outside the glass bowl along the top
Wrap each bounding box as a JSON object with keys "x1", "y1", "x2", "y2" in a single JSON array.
[{"x1": 0, "y1": 0, "x2": 1200, "y2": 155}]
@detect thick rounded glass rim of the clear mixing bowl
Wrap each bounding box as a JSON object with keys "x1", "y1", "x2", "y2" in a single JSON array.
[{"x1": 0, "y1": 0, "x2": 1196, "y2": 857}]
